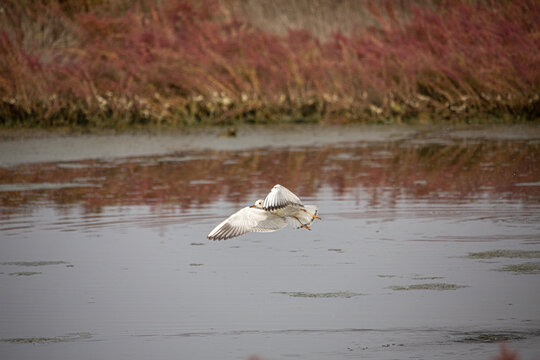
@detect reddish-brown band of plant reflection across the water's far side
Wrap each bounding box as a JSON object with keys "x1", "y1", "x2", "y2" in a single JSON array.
[{"x1": 0, "y1": 140, "x2": 540, "y2": 213}]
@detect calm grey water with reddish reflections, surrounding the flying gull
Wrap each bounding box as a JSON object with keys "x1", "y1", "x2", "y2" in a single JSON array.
[{"x1": 0, "y1": 128, "x2": 540, "y2": 359}]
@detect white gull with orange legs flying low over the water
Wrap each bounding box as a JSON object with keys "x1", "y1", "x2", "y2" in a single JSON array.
[{"x1": 207, "y1": 184, "x2": 321, "y2": 240}]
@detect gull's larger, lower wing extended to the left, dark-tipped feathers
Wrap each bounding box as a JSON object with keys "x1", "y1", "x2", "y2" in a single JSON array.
[{"x1": 207, "y1": 207, "x2": 287, "y2": 240}]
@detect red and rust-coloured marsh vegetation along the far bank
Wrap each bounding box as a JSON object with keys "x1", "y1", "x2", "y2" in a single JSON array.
[{"x1": 0, "y1": 0, "x2": 540, "y2": 127}]
